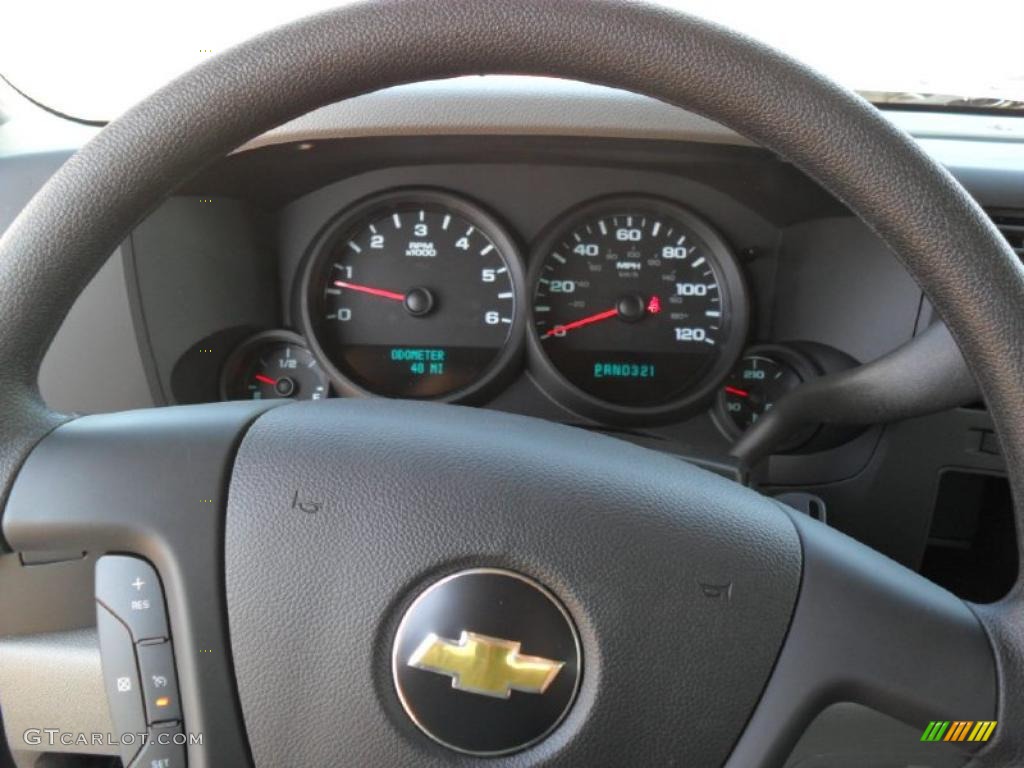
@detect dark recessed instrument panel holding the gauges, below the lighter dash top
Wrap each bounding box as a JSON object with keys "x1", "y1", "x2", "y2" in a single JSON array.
[{"x1": 130, "y1": 138, "x2": 922, "y2": 458}]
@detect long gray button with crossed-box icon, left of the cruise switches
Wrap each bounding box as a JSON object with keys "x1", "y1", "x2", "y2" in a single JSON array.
[{"x1": 96, "y1": 604, "x2": 145, "y2": 765}]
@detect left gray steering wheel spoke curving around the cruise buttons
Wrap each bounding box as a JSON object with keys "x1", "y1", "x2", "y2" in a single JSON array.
[{"x1": 3, "y1": 402, "x2": 273, "y2": 768}]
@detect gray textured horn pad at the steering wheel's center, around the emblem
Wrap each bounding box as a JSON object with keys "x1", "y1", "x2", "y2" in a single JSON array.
[{"x1": 225, "y1": 399, "x2": 801, "y2": 768}]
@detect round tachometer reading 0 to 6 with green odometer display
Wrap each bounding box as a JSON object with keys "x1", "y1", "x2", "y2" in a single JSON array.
[{"x1": 302, "y1": 189, "x2": 524, "y2": 399}]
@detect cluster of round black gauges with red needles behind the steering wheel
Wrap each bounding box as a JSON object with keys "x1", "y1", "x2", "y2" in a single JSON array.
[{"x1": 221, "y1": 188, "x2": 802, "y2": 435}]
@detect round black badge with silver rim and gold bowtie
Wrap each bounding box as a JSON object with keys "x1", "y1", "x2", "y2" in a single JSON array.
[{"x1": 391, "y1": 568, "x2": 583, "y2": 756}]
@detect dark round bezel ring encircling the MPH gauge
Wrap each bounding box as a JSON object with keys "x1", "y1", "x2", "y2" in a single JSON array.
[{"x1": 527, "y1": 194, "x2": 750, "y2": 426}]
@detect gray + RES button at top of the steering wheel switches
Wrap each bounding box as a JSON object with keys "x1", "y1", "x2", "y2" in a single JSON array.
[{"x1": 96, "y1": 555, "x2": 169, "y2": 642}]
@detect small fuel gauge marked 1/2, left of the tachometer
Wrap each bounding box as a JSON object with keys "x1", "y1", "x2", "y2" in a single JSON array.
[{"x1": 220, "y1": 331, "x2": 328, "y2": 400}]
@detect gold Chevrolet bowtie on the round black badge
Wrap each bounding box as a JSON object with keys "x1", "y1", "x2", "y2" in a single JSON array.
[{"x1": 409, "y1": 632, "x2": 564, "y2": 698}]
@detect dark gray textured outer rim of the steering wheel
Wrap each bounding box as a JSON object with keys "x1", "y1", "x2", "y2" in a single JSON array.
[{"x1": 0, "y1": 0, "x2": 1024, "y2": 763}]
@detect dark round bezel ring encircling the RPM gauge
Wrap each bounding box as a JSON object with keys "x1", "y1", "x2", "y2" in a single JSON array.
[{"x1": 296, "y1": 186, "x2": 527, "y2": 403}]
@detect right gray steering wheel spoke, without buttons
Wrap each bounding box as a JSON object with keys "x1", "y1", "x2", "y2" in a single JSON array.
[{"x1": 729, "y1": 510, "x2": 997, "y2": 768}]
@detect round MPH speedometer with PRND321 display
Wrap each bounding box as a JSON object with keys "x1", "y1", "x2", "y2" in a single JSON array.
[{"x1": 531, "y1": 198, "x2": 748, "y2": 421}]
